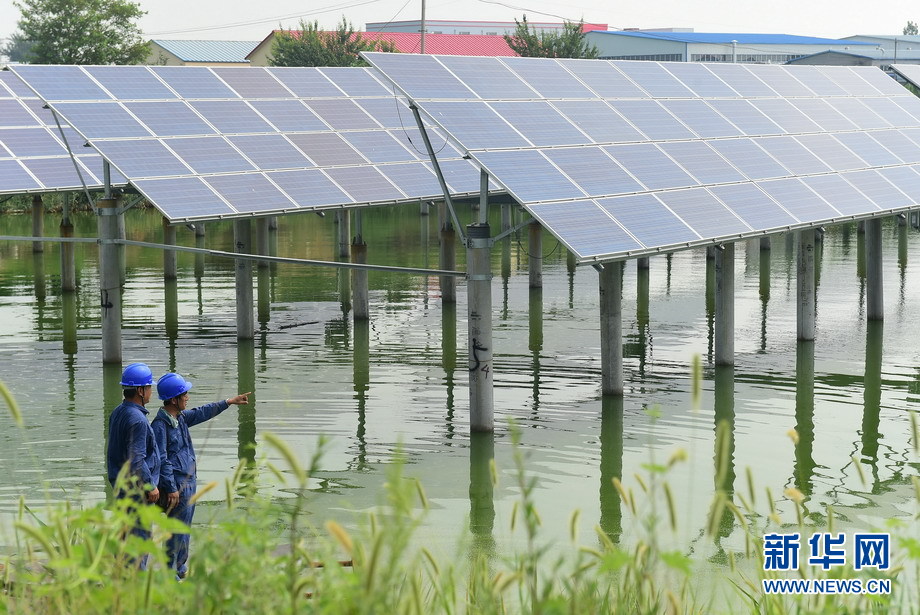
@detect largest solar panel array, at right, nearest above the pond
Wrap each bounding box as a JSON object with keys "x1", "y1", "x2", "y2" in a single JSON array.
[{"x1": 365, "y1": 53, "x2": 920, "y2": 262}]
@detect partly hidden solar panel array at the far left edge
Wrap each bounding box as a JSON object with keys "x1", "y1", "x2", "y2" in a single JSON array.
[{"x1": 0, "y1": 71, "x2": 125, "y2": 194}]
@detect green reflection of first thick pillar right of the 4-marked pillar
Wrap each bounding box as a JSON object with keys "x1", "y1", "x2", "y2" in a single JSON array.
[{"x1": 600, "y1": 395, "x2": 623, "y2": 544}]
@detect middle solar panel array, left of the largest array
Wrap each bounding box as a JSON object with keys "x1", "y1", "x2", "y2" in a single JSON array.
[{"x1": 14, "y1": 65, "x2": 479, "y2": 222}]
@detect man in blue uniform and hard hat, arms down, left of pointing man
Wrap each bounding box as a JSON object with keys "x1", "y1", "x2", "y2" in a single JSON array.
[{"x1": 106, "y1": 363, "x2": 160, "y2": 569}]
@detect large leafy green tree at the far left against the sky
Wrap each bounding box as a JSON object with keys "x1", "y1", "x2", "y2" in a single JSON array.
[{"x1": 13, "y1": 0, "x2": 148, "y2": 64}]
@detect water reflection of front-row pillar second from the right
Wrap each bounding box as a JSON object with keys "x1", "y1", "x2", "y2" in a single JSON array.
[{"x1": 794, "y1": 341, "x2": 815, "y2": 496}]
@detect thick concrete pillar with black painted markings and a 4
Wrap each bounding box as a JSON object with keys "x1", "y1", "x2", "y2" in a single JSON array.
[{"x1": 466, "y1": 223, "x2": 495, "y2": 431}]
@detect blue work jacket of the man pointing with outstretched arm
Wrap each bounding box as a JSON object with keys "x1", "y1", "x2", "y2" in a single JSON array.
[{"x1": 152, "y1": 400, "x2": 230, "y2": 493}]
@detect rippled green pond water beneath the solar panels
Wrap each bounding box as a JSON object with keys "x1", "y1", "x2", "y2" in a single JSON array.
[{"x1": 0, "y1": 206, "x2": 920, "y2": 576}]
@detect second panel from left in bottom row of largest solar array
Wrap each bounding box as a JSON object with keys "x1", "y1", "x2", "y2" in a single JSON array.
[{"x1": 598, "y1": 194, "x2": 700, "y2": 246}]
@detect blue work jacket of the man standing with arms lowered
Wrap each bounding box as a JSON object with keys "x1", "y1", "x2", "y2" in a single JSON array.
[{"x1": 106, "y1": 400, "x2": 160, "y2": 486}]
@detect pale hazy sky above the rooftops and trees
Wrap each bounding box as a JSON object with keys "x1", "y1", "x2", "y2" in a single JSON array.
[{"x1": 0, "y1": 0, "x2": 920, "y2": 40}]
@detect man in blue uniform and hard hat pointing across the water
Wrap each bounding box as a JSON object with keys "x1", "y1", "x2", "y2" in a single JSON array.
[{"x1": 152, "y1": 372, "x2": 252, "y2": 579}]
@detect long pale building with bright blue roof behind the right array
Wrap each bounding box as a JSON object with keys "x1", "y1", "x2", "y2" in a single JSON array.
[{"x1": 587, "y1": 30, "x2": 878, "y2": 64}]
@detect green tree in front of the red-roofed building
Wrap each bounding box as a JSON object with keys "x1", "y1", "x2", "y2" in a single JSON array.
[{"x1": 269, "y1": 17, "x2": 396, "y2": 66}]
